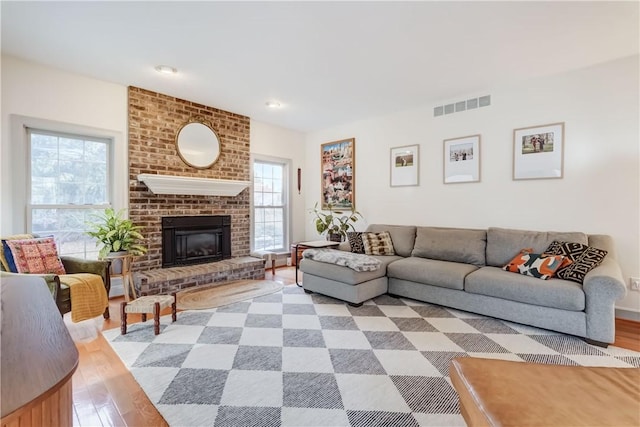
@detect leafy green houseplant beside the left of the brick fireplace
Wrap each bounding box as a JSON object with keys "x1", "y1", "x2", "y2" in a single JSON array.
[{"x1": 87, "y1": 208, "x2": 147, "y2": 258}]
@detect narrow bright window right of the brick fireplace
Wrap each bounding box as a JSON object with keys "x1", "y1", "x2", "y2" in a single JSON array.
[{"x1": 252, "y1": 159, "x2": 289, "y2": 251}]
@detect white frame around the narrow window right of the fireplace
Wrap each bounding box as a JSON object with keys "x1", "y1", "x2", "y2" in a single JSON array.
[{"x1": 250, "y1": 154, "x2": 292, "y2": 252}]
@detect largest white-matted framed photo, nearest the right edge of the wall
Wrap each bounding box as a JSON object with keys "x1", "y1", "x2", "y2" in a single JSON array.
[{"x1": 513, "y1": 122, "x2": 564, "y2": 180}]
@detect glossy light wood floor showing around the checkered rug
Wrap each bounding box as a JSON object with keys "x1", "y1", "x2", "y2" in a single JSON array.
[{"x1": 73, "y1": 267, "x2": 640, "y2": 427}]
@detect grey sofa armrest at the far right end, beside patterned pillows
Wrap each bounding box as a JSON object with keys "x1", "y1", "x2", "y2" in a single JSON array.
[{"x1": 582, "y1": 257, "x2": 627, "y2": 343}]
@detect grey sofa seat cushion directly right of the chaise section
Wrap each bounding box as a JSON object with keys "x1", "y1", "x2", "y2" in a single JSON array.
[{"x1": 387, "y1": 257, "x2": 478, "y2": 290}]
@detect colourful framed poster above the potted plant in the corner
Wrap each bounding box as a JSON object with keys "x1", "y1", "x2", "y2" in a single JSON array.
[{"x1": 320, "y1": 138, "x2": 356, "y2": 210}]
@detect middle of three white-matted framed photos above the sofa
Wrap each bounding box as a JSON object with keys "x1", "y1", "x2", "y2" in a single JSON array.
[{"x1": 443, "y1": 135, "x2": 480, "y2": 184}]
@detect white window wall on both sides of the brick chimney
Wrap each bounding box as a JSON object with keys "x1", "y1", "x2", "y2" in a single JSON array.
[{"x1": 0, "y1": 56, "x2": 305, "y2": 247}]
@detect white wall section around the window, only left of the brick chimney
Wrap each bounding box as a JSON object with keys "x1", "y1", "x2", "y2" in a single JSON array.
[{"x1": 0, "y1": 56, "x2": 128, "y2": 235}]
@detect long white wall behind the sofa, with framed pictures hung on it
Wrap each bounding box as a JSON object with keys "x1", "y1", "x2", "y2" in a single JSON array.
[{"x1": 305, "y1": 56, "x2": 640, "y2": 312}]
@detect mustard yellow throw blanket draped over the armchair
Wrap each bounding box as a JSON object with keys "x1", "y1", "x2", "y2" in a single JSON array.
[{"x1": 60, "y1": 273, "x2": 109, "y2": 323}]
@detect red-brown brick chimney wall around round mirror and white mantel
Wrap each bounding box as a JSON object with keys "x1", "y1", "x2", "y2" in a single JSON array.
[{"x1": 128, "y1": 86, "x2": 251, "y2": 271}]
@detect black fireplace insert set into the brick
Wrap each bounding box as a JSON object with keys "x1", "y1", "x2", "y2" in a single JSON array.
[{"x1": 162, "y1": 215, "x2": 231, "y2": 268}]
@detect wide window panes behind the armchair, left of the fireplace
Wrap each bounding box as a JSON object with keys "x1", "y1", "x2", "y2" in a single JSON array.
[{"x1": 27, "y1": 128, "x2": 112, "y2": 259}]
